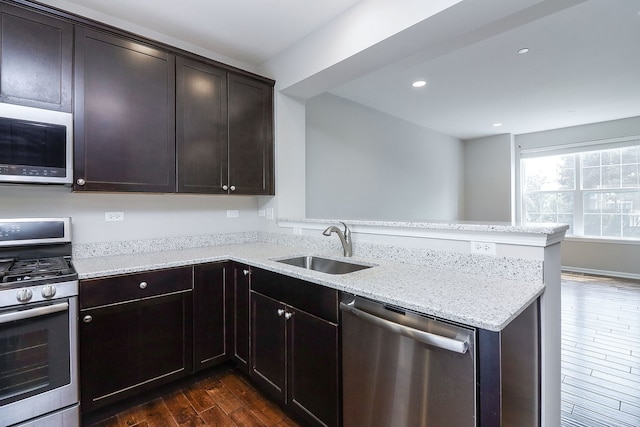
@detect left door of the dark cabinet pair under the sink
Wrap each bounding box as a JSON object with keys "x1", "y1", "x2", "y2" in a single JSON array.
[{"x1": 251, "y1": 292, "x2": 285, "y2": 401}]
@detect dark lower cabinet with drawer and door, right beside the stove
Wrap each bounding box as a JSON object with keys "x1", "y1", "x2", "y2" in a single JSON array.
[{"x1": 79, "y1": 267, "x2": 193, "y2": 413}]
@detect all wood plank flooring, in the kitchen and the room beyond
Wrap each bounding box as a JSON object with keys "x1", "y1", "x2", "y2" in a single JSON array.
[{"x1": 86, "y1": 274, "x2": 640, "y2": 427}]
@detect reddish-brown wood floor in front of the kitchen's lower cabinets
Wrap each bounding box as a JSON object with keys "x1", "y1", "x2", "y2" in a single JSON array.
[{"x1": 84, "y1": 368, "x2": 299, "y2": 427}]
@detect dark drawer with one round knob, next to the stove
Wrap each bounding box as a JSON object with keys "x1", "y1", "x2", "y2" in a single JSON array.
[{"x1": 80, "y1": 267, "x2": 193, "y2": 309}]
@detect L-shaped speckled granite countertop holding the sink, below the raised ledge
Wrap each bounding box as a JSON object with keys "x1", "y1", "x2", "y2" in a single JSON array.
[{"x1": 74, "y1": 243, "x2": 545, "y2": 331}]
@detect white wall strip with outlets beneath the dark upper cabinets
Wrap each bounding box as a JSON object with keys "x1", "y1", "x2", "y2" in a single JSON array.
[{"x1": 0, "y1": 185, "x2": 269, "y2": 243}]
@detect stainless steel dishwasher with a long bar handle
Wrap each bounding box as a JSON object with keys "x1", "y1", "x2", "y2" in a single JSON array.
[{"x1": 340, "y1": 295, "x2": 476, "y2": 427}]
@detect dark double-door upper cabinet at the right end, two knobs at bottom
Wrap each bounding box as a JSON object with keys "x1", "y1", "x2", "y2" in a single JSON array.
[{"x1": 176, "y1": 57, "x2": 273, "y2": 194}]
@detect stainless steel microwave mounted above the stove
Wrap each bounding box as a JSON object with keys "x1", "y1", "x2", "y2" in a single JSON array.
[{"x1": 0, "y1": 103, "x2": 73, "y2": 184}]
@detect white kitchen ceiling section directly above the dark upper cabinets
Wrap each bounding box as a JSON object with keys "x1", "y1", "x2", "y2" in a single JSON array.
[{"x1": 36, "y1": 0, "x2": 360, "y2": 67}]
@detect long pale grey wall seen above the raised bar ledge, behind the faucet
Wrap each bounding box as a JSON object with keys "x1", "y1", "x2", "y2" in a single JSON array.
[{"x1": 306, "y1": 94, "x2": 463, "y2": 220}]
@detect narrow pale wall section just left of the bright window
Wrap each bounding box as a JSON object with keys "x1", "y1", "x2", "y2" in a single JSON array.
[{"x1": 464, "y1": 134, "x2": 512, "y2": 221}]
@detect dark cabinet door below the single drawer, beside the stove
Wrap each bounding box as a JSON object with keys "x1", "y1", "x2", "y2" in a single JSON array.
[{"x1": 79, "y1": 291, "x2": 192, "y2": 412}]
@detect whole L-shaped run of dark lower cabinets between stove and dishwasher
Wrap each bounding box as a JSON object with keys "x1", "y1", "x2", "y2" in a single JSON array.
[{"x1": 79, "y1": 262, "x2": 342, "y2": 426}]
